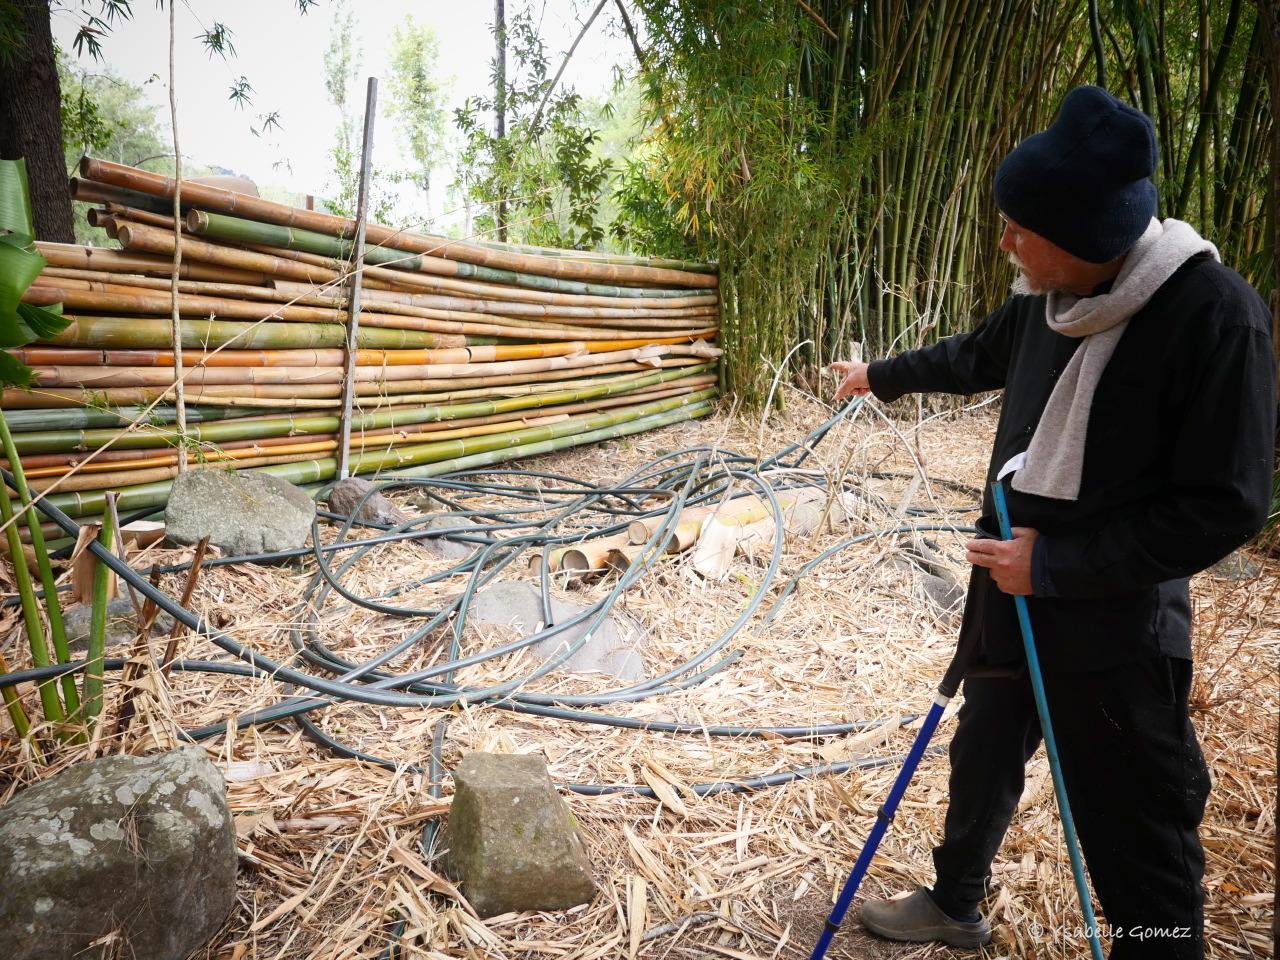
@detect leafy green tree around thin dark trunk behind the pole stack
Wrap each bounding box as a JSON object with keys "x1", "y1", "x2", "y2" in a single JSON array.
[{"x1": 454, "y1": 8, "x2": 613, "y2": 250}]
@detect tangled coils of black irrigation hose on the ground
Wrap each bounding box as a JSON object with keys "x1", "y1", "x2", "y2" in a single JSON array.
[{"x1": 0, "y1": 401, "x2": 968, "y2": 796}]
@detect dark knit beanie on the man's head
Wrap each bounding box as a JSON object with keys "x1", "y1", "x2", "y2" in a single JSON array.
[{"x1": 996, "y1": 87, "x2": 1156, "y2": 264}]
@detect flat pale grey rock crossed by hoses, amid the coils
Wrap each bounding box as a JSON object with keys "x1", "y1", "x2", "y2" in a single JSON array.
[{"x1": 467, "y1": 580, "x2": 648, "y2": 684}]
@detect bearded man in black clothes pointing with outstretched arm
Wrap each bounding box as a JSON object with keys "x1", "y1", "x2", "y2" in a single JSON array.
[{"x1": 835, "y1": 87, "x2": 1275, "y2": 960}]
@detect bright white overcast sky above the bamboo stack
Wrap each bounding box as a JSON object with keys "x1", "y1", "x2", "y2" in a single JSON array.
[{"x1": 54, "y1": 0, "x2": 635, "y2": 209}]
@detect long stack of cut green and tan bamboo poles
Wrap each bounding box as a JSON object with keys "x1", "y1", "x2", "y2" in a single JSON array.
[{"x1": 3, "y1": 157, "x2": 721, "y2": 516}]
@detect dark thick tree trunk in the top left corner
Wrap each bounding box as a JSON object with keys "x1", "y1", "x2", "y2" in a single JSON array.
[{"x1": 0, "y1": 0, "x2": 76, "y2": 243}]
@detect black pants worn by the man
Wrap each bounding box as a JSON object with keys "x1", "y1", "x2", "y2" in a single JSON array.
[{"x1": 933, "y1": 657, "x2": 1210, "y2": 960}]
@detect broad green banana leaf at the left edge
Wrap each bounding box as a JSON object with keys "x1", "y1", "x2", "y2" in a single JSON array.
[{"x1": 0, "y1": 160, "x2": 70, "y2": 387}]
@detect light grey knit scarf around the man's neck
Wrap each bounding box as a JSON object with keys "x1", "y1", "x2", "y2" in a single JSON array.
[{"x1": 1001, "y1": 219, "x2": 1221, "y2": 500}]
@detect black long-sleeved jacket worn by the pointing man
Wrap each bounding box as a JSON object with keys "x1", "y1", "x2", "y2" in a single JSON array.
[{"x1": 868, "y1": 255, "x2": 1276, "y2": 669}]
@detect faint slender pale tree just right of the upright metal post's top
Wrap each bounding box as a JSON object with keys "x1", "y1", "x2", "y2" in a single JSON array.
[{"x1": 387, "y1": 17, "x2": 448, "y2": 212}]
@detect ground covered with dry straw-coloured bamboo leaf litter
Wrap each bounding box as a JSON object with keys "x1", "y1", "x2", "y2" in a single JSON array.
[{"x1": 0, "y1": 397, "x2": 1280, "y2": 960}]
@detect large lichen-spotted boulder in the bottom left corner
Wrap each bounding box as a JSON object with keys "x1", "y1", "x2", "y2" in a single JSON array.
[{"x1": 0, "y1": 746, "x2": 236, "y2": 960}]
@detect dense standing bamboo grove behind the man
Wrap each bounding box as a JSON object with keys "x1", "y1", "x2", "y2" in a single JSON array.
[{"x1": 636, "y1": 0, "x2": 1280, "y2": 407}]
